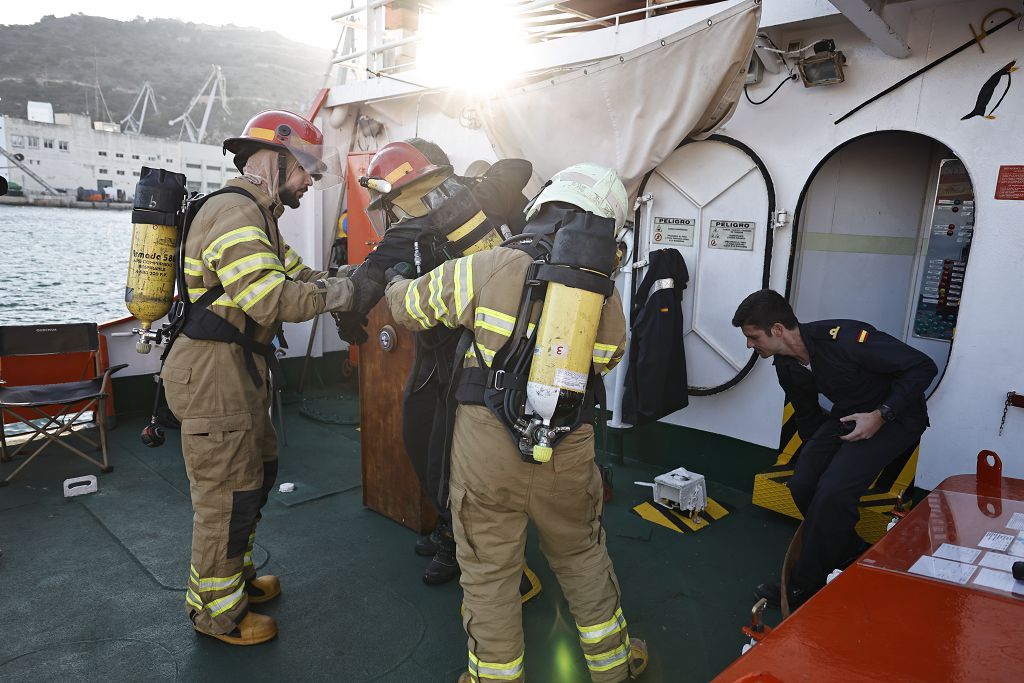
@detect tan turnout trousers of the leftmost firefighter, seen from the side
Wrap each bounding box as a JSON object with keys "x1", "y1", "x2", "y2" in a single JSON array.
[{"x1": 161, "y1": 335, "x2": 278, "y2": 633}]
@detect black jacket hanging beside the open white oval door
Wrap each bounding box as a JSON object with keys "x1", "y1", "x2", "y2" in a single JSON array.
[{"x1": 622, "y1": 249, "x2": 690, "y2": 425}]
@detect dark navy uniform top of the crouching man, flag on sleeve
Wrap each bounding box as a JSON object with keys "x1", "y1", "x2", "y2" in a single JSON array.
[{"x1": 774, "y1": 319, "x2": 938, "y2": 440}]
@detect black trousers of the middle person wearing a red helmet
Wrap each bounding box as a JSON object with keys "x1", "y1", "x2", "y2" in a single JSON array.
[{"x1": 401, "y1": 331, "x2": 460, "y2": 526}]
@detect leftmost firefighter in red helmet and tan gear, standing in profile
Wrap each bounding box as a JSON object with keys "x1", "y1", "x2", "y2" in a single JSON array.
[{"x1": 161, "y1": 112, "x2": 376, "y2": 645}]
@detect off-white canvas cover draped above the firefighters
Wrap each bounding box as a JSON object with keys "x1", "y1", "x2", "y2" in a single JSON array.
[{"x1": 479, "y1": 0, "x2": 761, "y2": 196}]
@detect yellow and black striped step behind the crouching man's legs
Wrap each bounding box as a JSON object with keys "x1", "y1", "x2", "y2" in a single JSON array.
[{"x1": 753, "y1": 403, "x2": 919, "y2": 543}]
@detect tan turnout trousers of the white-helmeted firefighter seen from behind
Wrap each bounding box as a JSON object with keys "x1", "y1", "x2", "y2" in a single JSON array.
[{"x1": 450, "y1": 405, "x2": 630, "y2": 683}]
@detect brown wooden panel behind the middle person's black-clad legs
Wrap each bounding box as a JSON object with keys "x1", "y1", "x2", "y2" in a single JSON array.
[{"x1": 359, "y1": 300, "x2": 437, "y2": 533}]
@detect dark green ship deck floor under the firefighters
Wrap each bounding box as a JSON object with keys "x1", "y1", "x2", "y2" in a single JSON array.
[{"x1": 0, "y1": 389, "x2": 795, "y2": 683}]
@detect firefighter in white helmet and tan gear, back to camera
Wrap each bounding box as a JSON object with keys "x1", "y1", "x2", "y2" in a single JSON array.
[{"x1": 386, "y1": 164, "x2": 647, "y2": 683}]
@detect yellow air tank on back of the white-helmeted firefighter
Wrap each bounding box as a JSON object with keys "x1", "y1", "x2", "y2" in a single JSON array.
[{"x1": 526, "y1": 214, "x2": 615, "y2": 463}]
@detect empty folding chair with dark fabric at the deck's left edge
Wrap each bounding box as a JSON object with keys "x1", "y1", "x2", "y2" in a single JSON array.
[{"x1": 0, "y1": 323, "x2": 127, "y2": 486}]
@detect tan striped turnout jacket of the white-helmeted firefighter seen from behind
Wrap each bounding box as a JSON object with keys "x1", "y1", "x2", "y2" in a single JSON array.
[{"x1": 385, "y1": 247, "x2": 626, "y2": 375}]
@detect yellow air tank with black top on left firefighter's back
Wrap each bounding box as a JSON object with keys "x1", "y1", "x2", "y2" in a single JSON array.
[{"x1": 125, "y1": 166, "x2": 187, "y2": 353}]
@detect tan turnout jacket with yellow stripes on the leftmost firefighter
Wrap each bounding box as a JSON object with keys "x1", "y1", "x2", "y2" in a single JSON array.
[{"x1": 183, "y1": 178, "x2": 352, "y2": 344}]
